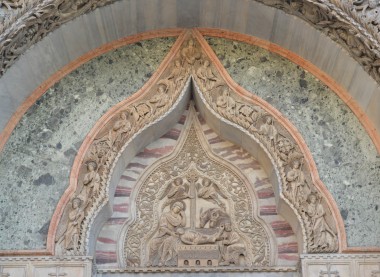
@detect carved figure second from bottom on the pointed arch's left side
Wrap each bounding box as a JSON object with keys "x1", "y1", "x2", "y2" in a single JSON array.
[{"x1": 78, "y1": 161, "x2": 100, "y2": 208}]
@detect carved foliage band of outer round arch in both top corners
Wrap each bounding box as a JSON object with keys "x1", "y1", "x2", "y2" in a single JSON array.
[{"x1": 0, "y1": 0, "x2": 380, "y2": 82}]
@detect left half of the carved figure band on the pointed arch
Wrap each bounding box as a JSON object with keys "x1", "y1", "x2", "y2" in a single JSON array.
[{"x1": 56, "y1": 34, "x2": 193, "y2": 255}]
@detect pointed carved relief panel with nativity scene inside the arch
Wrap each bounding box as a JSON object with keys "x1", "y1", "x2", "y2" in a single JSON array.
[{"x1": 123, "y1": 108, "x2": 275, "y2": 268}]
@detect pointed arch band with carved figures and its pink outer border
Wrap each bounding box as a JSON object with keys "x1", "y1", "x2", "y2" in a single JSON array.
[{"x1": 49, "y1": 31, "x2": 345, "y2": 264}]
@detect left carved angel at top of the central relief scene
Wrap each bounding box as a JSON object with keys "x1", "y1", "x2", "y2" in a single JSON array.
[{"x1": 160, "y1": 177, "x2": 192, "y2": 210}]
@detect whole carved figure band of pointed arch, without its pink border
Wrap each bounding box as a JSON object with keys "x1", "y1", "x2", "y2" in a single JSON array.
[{"x1": 55, "y1": 33, "x2": 339, "y2": 264}]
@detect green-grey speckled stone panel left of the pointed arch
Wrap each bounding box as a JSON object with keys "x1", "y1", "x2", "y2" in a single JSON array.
[{"x1": 0, "y1": 35, "x2": 175, "y2": 249}]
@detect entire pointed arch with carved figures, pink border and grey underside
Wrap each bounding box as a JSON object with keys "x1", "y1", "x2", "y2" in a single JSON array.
[{"x1": 49, "y1": 31, "x2": 345, "y2": 270}]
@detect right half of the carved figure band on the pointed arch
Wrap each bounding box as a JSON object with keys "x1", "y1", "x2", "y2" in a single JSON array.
[{"x1": 193, "y1": 38, "x2": 338, "y2": 253}]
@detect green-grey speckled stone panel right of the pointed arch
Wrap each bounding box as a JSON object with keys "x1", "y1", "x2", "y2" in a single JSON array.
[{"x1": 207, "y1": 38, "x2": 380, "y2": 246}]
